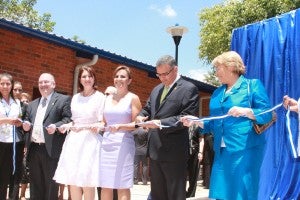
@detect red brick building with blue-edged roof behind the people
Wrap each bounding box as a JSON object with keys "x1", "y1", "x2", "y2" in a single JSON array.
[{"x1": 0, "y1": 19, "x2": 215, "y2": 116}]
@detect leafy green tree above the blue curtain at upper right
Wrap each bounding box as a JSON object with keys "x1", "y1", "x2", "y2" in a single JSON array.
[{"x1": 199, "y1": 0, "x2": 300, "y2": 83}]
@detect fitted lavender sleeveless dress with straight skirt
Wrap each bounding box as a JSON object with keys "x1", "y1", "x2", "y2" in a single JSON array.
[{"x1": 100, "y1": 93, "x2": 135, "y2": 189}]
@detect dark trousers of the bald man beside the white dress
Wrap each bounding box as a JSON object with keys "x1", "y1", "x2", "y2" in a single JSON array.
[{"x1": 28, "y1": 143, "x2": 58, "y2": 200}]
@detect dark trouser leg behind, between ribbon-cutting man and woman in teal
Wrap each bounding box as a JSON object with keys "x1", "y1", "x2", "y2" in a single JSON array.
[{"x1": 186, "y1": 149, "x2": 200, "y2": 198}]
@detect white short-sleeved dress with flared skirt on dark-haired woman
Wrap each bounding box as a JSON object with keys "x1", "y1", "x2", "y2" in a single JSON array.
[{"x1": 53, "y1": 91, "x2": 105, "y2": 187}]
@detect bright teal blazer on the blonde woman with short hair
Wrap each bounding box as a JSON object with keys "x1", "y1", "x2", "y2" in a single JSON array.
[{"x1": 200, "y1": 75, "x2": 272, "y2": 153}]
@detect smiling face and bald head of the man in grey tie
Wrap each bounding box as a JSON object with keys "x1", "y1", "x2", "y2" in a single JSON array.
[{"x1": 39, "y1": 73, "x2": 55, "y2": 97}]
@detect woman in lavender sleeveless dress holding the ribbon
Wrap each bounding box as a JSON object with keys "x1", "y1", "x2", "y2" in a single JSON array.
[{"x1": 100, "y1": 66, "x2": 142, "y2": 200}]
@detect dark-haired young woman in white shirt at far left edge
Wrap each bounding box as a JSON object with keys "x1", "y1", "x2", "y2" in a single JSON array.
[{"x1": 0, "y1": 73, "x2": 22, "y2": 199}]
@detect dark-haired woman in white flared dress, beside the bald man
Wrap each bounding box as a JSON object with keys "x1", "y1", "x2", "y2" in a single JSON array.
[{"x1": 53, "y1": 66, "x2": 105, "y2": 200}]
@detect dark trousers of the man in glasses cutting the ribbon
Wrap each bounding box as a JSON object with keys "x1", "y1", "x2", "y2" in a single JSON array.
[{"x1": 150, "y1": 159, "x2": 187, "y2": 200}]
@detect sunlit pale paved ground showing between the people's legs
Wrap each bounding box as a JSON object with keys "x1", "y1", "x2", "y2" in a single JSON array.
[{"x1": 22, "y1": 181, "x2": 209, "y2": 200}]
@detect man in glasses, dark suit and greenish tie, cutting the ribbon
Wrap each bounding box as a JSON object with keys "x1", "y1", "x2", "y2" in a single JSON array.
[{"x1": 136, "y1": 56, "x2": 199, "y2": 200}]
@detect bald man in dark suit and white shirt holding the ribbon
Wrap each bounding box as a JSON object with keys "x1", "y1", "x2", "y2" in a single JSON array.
[{"x1": 23, "y1": 73, "x2": 71, "y2": 200}]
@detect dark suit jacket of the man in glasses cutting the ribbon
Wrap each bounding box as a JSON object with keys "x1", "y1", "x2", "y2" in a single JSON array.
[{"x1": 140, "y1": 78, "x2": 199, "y2": 161}]
